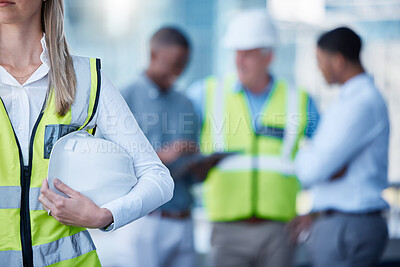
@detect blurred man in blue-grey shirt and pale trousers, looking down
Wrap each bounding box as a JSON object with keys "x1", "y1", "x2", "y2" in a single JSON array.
[{"x1": 120, "y1": 27, "x2": 198, "y2": 267}]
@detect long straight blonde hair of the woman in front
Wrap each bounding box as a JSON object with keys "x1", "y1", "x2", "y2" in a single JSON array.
[{"x1": 42, "y1": 0, "x2": 76, "y2": 116}]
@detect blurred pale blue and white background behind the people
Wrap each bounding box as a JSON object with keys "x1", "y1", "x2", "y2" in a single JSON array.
[{"x1": 65, "y1": 0, "x2": 400, "y2": 266}]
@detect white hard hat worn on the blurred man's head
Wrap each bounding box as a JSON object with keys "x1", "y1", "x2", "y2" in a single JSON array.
[{"x1": 222, "y1": 9, "x2": 278, "y2": 50}]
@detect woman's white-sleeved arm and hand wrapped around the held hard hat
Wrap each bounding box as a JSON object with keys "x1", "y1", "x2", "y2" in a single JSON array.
[{"x1": 40, "y1": 72, "x2": 174, "y2": 231}]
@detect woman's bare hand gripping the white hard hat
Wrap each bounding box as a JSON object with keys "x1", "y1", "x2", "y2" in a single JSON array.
[{"x1": 39, "y1": 178, "x2": 113, "y2": 228}]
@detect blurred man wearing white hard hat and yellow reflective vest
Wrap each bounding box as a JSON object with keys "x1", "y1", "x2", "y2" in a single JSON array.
[{"x1": 188, "y1": 10, "x2": 318, "y2": 267}]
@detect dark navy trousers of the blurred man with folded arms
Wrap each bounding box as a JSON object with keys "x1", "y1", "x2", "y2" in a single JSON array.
[{"x1": 309, "y1": 213, "x2": 388, "y2": 267}]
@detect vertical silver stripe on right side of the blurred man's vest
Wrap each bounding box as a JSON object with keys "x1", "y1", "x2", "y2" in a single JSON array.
[{"x1": 281, "y1": 87, "x2": 300, "y2": 160}]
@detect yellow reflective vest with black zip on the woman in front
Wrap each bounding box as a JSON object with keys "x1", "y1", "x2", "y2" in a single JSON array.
[{"x1": 0, "y1": 57, "x2": 101, "y2": 267}]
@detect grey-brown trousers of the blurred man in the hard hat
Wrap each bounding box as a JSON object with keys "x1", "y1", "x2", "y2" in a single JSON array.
[{"x1": 210, "y1": 221, "x2": 294, "y2": 267}]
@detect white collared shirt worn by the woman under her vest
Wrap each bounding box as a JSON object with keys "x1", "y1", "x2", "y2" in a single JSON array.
[{"x1": 0, "y1": 36, "x2": 174, "y2": 230}]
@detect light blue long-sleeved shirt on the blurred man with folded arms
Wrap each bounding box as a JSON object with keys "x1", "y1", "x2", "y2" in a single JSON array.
[{"x1": 296, "y1": 73, "x2": 389, "y2": 213}]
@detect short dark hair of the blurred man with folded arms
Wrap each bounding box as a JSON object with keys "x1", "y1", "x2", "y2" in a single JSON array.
[{"x1": 317, "y1": 27, "x2": 362, "y2": 63}]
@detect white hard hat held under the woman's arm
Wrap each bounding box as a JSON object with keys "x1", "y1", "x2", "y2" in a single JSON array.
[{"x1": 47, "y1": 131, "x2": 137, "y2": 206}]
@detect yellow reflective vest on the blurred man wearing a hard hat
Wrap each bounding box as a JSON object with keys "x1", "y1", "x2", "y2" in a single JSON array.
[{"x1": 200, "y1": 77, "x2": 308, "y2": 222}]
